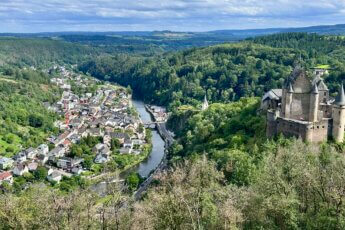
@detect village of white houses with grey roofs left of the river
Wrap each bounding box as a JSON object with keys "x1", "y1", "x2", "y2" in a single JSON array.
[{"x1": 0, "y1": 66, "x2": 148, "y2": 187}]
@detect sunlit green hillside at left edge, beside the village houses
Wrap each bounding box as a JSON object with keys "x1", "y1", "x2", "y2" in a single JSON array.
[{"x1": 0, "y1": 71, "x2": 59, "y2": 156}]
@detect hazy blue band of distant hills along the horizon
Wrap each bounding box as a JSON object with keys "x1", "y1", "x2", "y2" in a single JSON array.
[{"x1": 0, "y1": 24, "x2": 345, "y2": 54}]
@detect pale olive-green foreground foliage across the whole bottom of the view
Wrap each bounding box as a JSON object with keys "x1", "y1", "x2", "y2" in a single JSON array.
[{"x1": 0, "y1": 139, "x2": 345, "y2": 229}]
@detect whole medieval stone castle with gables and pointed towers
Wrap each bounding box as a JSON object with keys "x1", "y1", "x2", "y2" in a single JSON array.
[{"x1": 262, "y1": 66, "x2": 345, "y2": 142}]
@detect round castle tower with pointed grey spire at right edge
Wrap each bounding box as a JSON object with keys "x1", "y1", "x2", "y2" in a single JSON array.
[{"x1": 332, "y1": 84, "x2": 345, "y2": 142}]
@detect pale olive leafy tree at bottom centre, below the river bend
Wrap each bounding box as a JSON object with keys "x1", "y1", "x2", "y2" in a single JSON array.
[{"x1": 133, "y1": 157, "x2": 243, "y2": 229}]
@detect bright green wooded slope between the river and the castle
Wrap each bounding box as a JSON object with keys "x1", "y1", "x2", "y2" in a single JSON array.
[{"x1": 169, "y1": 98, "x2": 266, "y2": 185}]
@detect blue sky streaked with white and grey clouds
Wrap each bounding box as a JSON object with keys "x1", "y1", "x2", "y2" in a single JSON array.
[{"x1": 0, "y1": 0, "x2": 345, "y2": 33}]
